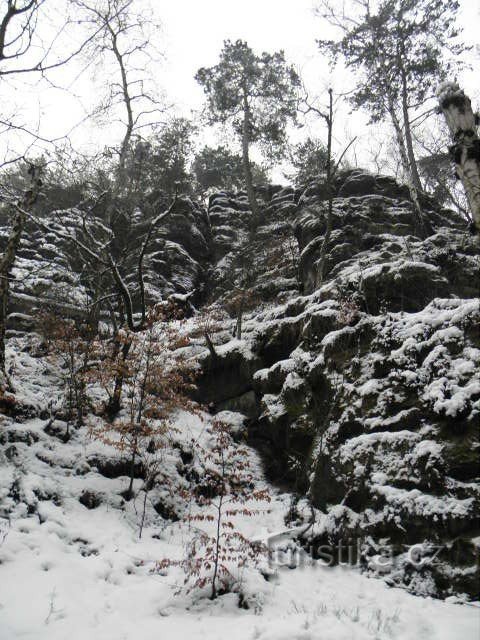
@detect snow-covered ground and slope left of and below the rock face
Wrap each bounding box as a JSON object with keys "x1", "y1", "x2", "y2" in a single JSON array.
[{"x1": 0, "y1": 336, "x2": 480, "y2": 640}]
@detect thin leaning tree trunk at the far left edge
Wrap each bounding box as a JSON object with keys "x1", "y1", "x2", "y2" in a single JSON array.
[{"x1": 0, "y1": 165, "x2": 42, "y2": 392}]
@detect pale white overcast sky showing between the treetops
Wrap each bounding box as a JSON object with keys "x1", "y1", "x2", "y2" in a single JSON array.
[{"x1": 1, "y1": 0, "x2": 480, "y2": 178}]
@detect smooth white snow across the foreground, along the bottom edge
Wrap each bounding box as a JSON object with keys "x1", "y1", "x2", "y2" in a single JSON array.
[{"x1": 0, "y1": 501, "x2": 479, "y2": 640}]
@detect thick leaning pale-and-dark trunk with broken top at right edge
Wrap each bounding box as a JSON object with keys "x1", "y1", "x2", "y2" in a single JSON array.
[{"x1": 438, "y1": 82, "x2": 480, "y2": 233}]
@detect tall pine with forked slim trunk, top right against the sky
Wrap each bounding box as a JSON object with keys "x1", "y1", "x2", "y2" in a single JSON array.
[{"x1": 319, "y1": 0, "x2": 465, "y2": 230}]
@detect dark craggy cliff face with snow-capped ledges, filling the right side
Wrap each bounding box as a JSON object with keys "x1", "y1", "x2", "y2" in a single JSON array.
[{"x1": 2, "y1": 171, "x2": 480, "y2": 595}]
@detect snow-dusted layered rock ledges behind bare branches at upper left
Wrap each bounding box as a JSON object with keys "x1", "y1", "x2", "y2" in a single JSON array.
[{"x1": 0, "y1": 198, "x2": 210, "y2": 331}]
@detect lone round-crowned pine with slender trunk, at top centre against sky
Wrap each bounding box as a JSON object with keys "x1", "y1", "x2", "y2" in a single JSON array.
[{"x1": 195, "y1": 40, "x2": 300, "y2": 221}]
